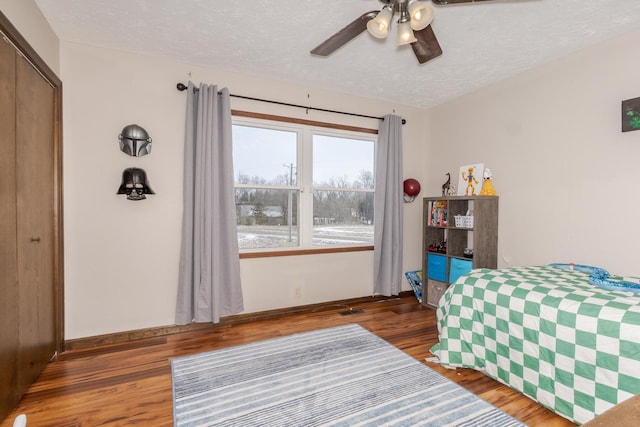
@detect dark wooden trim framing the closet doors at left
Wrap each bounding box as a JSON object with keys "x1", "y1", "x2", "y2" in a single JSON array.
[{"x1": 0, "y1": 12, "x2": 64, "y2": 354}]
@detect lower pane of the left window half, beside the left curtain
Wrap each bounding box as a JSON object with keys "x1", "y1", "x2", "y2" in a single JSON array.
[{"x1": 236, "y1": 188, "x2": 300, "y2": 249}]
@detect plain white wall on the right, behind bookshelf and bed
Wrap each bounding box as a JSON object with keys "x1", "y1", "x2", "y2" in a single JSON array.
[{"x1": 426, "y1": 32, "x2": 640, "y2": 276}]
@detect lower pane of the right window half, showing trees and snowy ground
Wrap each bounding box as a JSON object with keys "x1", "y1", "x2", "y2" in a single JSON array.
[{"x1": 313, "y1": 190, "x2": 373, "y2": 246}]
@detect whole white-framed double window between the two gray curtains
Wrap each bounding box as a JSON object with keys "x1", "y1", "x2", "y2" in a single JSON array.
[{"x1": 233, "y1": 118, "x2": 376, "y2": 252}]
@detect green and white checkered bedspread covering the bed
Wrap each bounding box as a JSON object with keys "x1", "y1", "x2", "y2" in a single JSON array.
[{"x1": 431, "y1": 266, "x2": 640, "y2": 424}]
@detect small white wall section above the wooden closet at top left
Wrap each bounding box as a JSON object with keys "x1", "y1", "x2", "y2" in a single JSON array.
[{"x1": 0, "y1": 0, "x2": 60, "y2": 76}]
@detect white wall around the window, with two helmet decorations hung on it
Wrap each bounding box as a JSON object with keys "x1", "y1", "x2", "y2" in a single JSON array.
[{"x1": 60, "y1": 42, "x2": 428, "y2": 339}]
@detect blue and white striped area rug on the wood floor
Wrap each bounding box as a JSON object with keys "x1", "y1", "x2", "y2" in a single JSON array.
[{"x1": 171, "y1": 324, "x2": 524, "y2": 427}]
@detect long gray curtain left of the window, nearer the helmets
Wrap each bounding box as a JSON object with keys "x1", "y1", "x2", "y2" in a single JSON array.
[{"x1": 176, "y1": 82, "x2": 244, "y2": 325}]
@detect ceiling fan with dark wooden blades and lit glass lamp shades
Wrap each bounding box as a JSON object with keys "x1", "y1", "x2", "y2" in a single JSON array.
[{"x1": 311, "y1": 0, "x2": 498, "y2": 64}]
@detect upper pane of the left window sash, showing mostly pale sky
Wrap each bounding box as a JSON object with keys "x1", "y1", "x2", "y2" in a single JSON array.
[{"x1": 233, "y1": 125, "x2": 298, "y2": 185}]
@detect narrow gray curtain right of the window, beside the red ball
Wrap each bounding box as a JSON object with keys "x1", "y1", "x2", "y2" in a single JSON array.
[{"x1": 373, "y1": 114, "x2": 403, "y2": 296}]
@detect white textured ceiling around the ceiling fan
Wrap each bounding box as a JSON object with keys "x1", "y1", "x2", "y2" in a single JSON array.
[{"x1": 35, "y1": 0, "x2": 640, "y2": 107}]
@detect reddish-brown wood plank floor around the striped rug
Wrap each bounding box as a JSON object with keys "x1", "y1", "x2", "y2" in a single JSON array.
[{"x1": 0, "y1": 297, "x2": 574, "y2": 427}]
